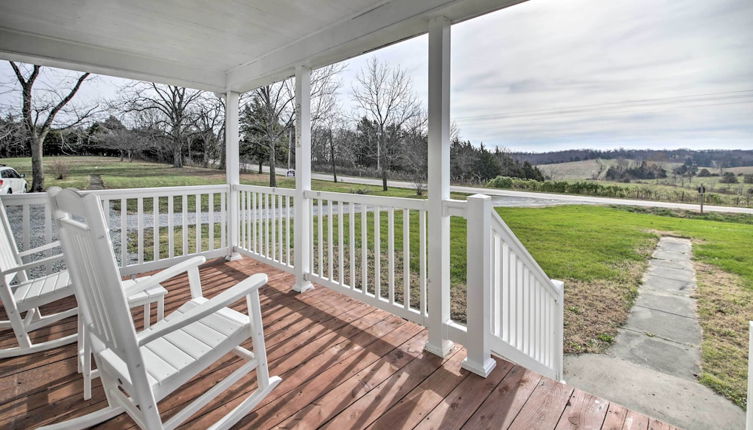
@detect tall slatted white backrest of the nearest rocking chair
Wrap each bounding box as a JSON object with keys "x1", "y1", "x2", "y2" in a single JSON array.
[{"x1": 49, "y1": 189, "x2": 147, "y2": 394}]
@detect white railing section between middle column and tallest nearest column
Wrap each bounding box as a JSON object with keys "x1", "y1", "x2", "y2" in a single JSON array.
[{"x1": 305, "y1": 191, "x2": 427, "y2": 325}]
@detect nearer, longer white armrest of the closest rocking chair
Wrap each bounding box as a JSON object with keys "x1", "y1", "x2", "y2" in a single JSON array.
[{"x1": 137, "y1": 273, "x2": 267, "y2": 346}]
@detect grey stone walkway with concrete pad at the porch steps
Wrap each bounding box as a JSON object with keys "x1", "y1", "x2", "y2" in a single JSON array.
[{"x1": 565, "y1": 237, "x2": 745, "y2": 430}]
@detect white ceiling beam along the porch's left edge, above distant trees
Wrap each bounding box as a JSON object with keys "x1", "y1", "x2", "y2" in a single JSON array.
[{"x1": 0, "y1": 28, "x2": 226, "y2": 92}]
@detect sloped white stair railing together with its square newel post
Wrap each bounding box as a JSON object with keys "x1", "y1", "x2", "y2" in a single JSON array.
[{"x1": 455, "y1": 195, "x2": 564, "y2": 380}]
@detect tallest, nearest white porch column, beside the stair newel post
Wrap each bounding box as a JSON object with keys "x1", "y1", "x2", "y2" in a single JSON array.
[{"x1": 425, "y1": 17, "x2": 452, "y2": 357}]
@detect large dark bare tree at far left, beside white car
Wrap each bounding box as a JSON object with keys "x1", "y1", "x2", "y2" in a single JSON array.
[{"x1": 9, "y1": 61, "x2": 97, "y2": 192}]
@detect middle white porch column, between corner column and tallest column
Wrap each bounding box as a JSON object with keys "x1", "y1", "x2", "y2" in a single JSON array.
[{"x1": 293, "y1": 66, "x2": 313, "y2": 293}]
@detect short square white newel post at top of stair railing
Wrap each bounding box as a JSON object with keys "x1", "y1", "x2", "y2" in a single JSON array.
[{"x1": 462, "y1": 194, "x2": 497, "y2": 378}]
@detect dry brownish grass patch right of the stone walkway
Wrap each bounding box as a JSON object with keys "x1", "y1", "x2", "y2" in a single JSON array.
[{"x1": 694, "y1": 262, "x2": 753, "y2": 408}]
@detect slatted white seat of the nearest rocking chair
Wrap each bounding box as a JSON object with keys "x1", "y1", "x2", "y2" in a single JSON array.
[{"x1": 97, "y1": 297, "x2": 250, "y2": 401}]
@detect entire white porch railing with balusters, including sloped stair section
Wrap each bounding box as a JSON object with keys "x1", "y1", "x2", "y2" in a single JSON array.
[{"x1": 2, "y1": 185, "x2": 563, "y2": 380}]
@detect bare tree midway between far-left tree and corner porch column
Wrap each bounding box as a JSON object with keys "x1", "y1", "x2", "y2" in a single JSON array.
[{"x1": 120, "y1": 82, "x2": 203, "y2": 167}]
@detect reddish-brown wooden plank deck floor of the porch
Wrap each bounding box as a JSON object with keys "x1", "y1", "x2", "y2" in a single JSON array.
[{"x1": 0, "y1": 259, "x2": 672, "y2": 430}]
